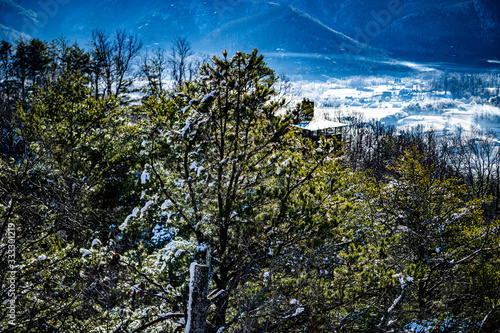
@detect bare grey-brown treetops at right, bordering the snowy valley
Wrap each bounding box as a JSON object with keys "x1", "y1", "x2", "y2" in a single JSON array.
[{"x1": 338, "y1": 115, "x2": 500, "y2": 217}]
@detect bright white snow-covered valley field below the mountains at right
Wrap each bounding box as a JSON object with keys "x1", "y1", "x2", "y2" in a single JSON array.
[{"x1": 291, "y1": 71, "x2": 500, "y2": 134}]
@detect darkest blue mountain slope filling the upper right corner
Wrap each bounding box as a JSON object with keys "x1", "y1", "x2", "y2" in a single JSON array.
[{"x1": 284, "y1": 0, "x2": 500, "y2": 62}]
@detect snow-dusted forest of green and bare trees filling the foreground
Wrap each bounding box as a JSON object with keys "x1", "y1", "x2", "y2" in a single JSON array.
[{"x1": 0, "y1": 30, "x2": 500, "y2": 333}]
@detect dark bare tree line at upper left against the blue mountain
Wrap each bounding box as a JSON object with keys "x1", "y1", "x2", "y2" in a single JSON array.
[{"x1": 0, "y1": 29, "x2": 203, "y2": 102}]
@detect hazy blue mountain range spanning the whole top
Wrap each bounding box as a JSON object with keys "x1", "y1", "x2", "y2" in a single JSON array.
[{"x1": 0, "y1": 0, "x2": 500, "y2": 76}]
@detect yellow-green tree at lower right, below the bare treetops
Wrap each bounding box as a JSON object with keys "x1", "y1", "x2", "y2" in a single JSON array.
[{"x1": 356, "y1": 149, "x2": 498, "y2": 328}]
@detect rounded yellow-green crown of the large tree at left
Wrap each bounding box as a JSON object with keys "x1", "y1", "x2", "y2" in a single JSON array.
[{"x1": 17, "y1": 73, "x2": 138, "y2": 218}]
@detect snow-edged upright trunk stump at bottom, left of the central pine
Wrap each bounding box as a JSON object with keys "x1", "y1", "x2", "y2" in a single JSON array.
[{"x1": 186, "y1": 262, "x2": 209, "y2": 333}]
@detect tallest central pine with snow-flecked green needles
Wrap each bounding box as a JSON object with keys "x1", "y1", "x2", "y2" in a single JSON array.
[{"x1": 115, "y1": 51, "x2": 346, "y2": 330}]
